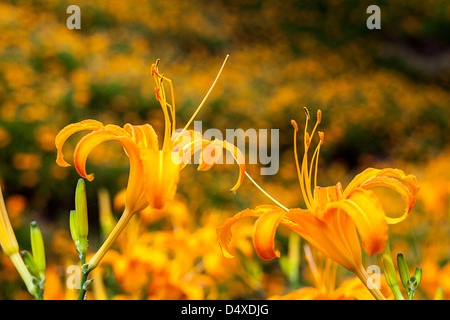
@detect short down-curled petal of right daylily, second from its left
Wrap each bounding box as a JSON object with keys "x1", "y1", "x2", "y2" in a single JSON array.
[{"x1": 253, "y1": 207, "x2": 285, "y2": 260}]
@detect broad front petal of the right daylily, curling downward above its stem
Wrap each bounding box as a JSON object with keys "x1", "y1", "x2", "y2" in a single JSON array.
[{"x1": 327, "y1": 189, "x2": 388, "y2": 255}]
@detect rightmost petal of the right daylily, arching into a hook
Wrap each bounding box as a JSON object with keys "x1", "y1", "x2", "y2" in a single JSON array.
[{"x1": 343, "y1": 168, "x2": 420, "y2": 224}]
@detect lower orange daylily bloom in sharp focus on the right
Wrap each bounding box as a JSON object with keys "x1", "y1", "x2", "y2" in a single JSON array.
[{"x1": 217, "y1": 108, "x2": 419, "y2": 298}]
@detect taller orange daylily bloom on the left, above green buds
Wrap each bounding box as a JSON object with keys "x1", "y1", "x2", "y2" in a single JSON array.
[{"x1": 55, "y1": 57, "x2": 245, "y2": 269}]
